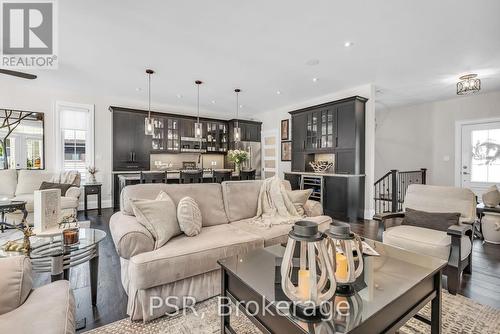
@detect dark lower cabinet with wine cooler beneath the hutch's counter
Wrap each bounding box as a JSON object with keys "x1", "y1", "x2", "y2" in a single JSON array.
[{"x1": 285, "y1": 172, "x2": 365, "y2": 222}]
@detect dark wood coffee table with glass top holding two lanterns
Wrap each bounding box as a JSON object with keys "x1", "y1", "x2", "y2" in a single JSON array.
[{"x1": 219, "y1": 240, "x2": 446, "y2": 334}]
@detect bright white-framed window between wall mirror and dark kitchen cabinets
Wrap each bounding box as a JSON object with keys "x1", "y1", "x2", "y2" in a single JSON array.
[{"x1": 56, "y1": 102, "x2": 94, "y2": 181}]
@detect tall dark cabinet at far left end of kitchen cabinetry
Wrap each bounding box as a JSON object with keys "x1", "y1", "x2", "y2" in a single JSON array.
[{"x1": 112, "y1": 109, "x2": 151, "y2": 171}]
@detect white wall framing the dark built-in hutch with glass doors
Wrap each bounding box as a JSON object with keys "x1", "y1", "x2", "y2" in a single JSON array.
[{"x1": 254, "y1": 84, "x2": 375, "y2": 219}]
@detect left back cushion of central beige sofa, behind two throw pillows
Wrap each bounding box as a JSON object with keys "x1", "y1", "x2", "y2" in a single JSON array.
[{"x1": 121, "y1": 183, "x2": 229, "y2": 226}]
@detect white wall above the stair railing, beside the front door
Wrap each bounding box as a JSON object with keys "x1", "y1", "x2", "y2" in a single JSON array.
[{"x1": 375, "y1": 92, "x2": 500, "y2": 186}]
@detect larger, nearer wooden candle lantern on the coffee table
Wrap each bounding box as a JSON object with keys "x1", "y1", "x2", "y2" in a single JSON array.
[{"x1": 281, "y1": 221, "x2": 336, "y2": 307}]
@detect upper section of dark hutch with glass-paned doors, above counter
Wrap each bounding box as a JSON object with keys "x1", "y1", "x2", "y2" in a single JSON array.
[{"x1": 290, "y1": 96, "x2": 367, "y2": 174}]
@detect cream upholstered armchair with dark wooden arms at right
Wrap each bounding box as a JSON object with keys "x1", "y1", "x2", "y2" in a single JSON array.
[{"x1": 374, "y1": 184, "x2": 476, "y2": 294}]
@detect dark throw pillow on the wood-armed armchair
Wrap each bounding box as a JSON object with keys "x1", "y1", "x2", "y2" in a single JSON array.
[{"x1": 401, "y1": 208, "x2": 460, "y2": 232}]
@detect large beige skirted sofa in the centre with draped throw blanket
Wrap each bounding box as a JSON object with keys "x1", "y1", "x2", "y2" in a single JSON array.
[{"x1": 110, "y1": 180, "x2": 331, "y2": 321}]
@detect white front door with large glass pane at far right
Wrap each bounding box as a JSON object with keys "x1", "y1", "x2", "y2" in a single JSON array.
[{"x1": 460, "y1": 122, "x2": 500, "y2": 199}]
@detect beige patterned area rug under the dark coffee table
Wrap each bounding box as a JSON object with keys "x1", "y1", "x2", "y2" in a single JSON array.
[{"x1": 86, "y1": 293, "x2": 500, "y2": 334}]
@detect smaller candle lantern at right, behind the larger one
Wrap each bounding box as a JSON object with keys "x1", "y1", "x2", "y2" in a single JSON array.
[{"x1": 325, "y1": 222, "x2": 363, "y2": 292}]
